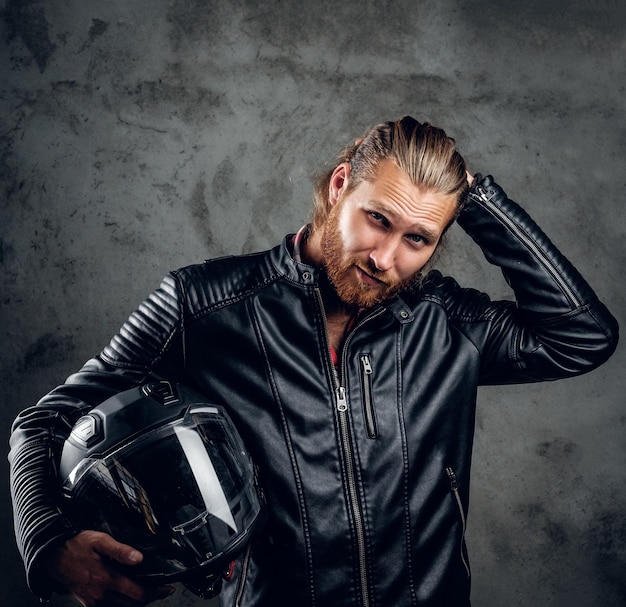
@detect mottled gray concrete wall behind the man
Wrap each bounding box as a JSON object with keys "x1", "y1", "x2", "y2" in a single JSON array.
[{"x1": 0, "y1": 0, "x2": 626, "y2": 607}]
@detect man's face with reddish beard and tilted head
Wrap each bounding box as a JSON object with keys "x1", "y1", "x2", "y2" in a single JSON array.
[{"x1": 322, "y1": 161, "x2": 456, "y2": 308}]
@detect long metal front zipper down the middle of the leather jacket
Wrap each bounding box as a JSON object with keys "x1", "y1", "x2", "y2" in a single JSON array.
[{"x1": 316, "y1": 290, "x2": 384, "y2": 607}]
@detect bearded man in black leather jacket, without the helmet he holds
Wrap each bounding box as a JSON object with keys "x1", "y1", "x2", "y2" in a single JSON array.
[{"x1": 10, "y1": 117, "x2": 618, "y2": 607}]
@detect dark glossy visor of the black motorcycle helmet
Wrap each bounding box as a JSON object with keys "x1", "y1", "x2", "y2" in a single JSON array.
[{"x1": 64, "y1": 406, "x2": 261, "y2": 577}]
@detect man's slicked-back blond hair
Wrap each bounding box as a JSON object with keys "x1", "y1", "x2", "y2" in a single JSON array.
[{"x1": 312, "y1": 116, "x2": 468, "y2": 230}]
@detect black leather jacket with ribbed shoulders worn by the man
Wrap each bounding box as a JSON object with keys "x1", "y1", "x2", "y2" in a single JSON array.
[{"x1": 10, "y1": 177, "x2": 617, "y2": 607}]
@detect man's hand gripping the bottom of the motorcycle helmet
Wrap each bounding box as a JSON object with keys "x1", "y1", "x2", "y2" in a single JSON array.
[{"x1": 49, "y1": 531, "x2": 174, "y2": 607}]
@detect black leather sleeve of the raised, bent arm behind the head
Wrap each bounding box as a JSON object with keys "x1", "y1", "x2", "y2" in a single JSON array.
[{"x1": 455, "y1": 176, "x2": 618, "y2": 384}]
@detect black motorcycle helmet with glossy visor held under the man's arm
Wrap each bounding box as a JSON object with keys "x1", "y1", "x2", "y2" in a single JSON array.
[{"x1": 60, "y1": 382, "x2": 264, "y2": 598}]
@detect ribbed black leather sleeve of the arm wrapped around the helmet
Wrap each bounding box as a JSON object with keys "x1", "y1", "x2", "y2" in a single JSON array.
[{"x1": 9, "y1": 274, "x2": 184, "y2": 596}]
